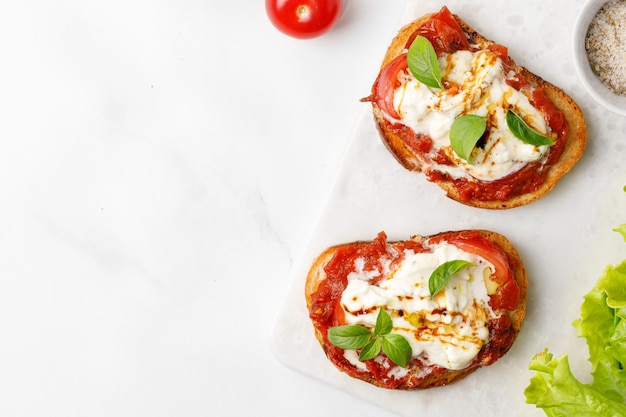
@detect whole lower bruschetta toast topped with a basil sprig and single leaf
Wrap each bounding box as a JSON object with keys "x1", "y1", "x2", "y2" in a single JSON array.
[{"x1": 305, "y1": 230, "x2": 528, "y2": 390}]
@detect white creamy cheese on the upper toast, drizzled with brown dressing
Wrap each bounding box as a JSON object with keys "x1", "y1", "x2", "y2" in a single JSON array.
[{"x1": 394, "y1": 50, "x2": 548, "y2": 181}]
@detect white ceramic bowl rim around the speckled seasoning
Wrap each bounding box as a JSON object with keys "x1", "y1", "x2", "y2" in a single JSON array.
[{"x1": 574, "y1": 0, "x2": 626, "y2": 116}]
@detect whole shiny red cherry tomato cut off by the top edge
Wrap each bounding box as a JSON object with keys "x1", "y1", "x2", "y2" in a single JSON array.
[{"x1": 265, "y1": 0, "x2": 342, "y2": 39}]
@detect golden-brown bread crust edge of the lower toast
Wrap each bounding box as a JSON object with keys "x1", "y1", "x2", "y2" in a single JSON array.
[{"x1": 304, "y1": 230, "x2": 528, "y2": 390}]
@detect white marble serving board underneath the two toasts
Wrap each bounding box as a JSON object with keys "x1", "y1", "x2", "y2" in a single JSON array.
[{"x1": 272, "y1": 0, "x2": 626, "y2": 417}]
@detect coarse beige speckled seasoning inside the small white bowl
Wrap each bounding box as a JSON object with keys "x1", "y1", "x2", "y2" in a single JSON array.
[{"x1": 585, "y1": 0, "x2": 626, "y2": 95}]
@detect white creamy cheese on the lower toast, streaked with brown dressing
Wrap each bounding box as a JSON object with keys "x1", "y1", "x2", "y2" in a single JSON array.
[{"x1": 341, "y1": 243, "x2": 495, "y2": 369}]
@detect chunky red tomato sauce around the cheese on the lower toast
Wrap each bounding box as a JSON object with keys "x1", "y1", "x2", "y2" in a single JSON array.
[{"x1": 309, "y1": 231, "x2": 520, "y2": 388}]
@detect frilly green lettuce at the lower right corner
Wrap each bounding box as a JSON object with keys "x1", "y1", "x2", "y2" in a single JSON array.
[{"x1": 524, "y1": 221, "x2": 626, "y2": 417}]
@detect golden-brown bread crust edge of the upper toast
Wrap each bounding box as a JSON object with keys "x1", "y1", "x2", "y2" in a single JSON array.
[{"x1": 372, "y1": 13, "x2": 587, "y2": 209}]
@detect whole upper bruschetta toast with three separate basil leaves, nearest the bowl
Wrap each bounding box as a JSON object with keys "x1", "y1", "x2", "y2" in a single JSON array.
[{"x1": 363, "y1": 7, "x2": 587, "y2": 209}]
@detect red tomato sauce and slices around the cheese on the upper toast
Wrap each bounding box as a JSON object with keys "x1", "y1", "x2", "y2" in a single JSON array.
[{"x1": 370, "y1": 6, "x2": 569, "y2": 201}]
